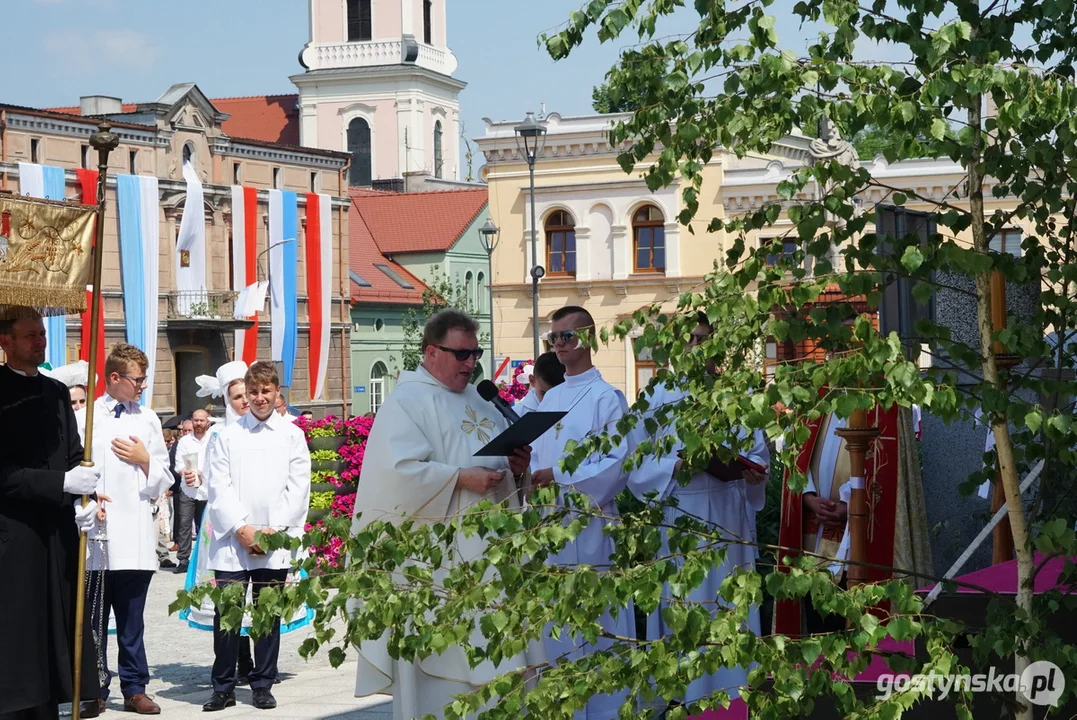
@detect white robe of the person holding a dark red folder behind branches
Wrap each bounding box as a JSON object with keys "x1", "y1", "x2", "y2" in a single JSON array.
[{"x1": 628, "y1": 385, "x2": 770, "y2": 702}]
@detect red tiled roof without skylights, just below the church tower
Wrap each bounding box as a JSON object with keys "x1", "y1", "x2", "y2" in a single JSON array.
[{"x1": 350, "y1": 187, "x2": 487, "y2": 255}]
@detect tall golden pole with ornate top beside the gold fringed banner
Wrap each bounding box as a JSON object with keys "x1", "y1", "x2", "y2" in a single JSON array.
[{"x1": 71, "y1": 122, "x2": 120, "y2": 720}]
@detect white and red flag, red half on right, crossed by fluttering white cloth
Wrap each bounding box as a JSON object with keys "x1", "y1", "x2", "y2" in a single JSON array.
[{"x1": 232, "y1": 185, "x2": 265, "y2": 366}]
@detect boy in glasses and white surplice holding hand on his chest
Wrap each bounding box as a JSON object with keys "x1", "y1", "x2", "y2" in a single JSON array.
[{"x1": 81, "y1": 343, "x2": 172, "y2": 718}]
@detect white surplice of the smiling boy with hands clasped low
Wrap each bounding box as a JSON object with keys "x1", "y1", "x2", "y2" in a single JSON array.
[{"x1": 205, "y1": 412, "x2": 310, "y2": 571}]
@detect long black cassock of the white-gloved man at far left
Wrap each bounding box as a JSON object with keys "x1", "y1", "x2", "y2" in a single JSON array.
[{"x1": 0, "y1": 366, "x2": 99, "y2": 714}]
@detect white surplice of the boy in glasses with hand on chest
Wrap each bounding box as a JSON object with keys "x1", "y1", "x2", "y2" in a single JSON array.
[{"x1": 87, "y1": 393, "x2": 173, "y2": 571}]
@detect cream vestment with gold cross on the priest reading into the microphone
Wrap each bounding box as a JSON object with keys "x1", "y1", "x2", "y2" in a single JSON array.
[{"x1": 352, "y1": 367, "x2": 542, "y2": 720}]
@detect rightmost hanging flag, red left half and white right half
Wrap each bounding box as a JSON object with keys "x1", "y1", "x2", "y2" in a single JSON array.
[{"x1": 306, "y1": 193, "x2": 333, "y2": 400}]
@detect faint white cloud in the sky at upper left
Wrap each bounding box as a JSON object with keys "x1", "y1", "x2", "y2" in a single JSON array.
[{"x1": 38, "y1": 28, "x2": 162, "y2": 75}]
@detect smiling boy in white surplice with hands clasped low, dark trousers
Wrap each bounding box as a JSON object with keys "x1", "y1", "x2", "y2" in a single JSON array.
[{"x1": 202, "y1": 361, "x2": 310, "y2": 712}]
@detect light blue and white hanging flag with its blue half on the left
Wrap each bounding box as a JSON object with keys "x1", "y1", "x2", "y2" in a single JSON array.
[{"x1": 116, "y1": 175, "x2": 160, "y2": 407}]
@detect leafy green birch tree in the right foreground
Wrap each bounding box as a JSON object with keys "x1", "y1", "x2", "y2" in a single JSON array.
[{"x1": 180, "y1": 0, "x2": 1077, "y2": 720}]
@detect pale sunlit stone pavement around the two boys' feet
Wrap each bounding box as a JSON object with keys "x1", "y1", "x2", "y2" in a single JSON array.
[{"x1": 61, "y1": 570, "x2": 392, "y2": 720}]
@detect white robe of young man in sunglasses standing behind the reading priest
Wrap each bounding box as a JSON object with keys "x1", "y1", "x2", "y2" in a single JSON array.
[{"x1": 531, "y1": 368, "x2": 635, "y2": 720}]
